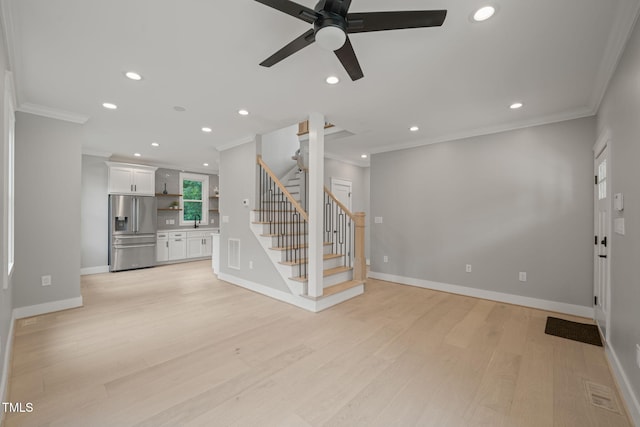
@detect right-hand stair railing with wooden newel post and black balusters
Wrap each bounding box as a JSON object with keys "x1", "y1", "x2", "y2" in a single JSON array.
[{"x1": 323, "y1": 187, "x2": 366, "y2": 281}]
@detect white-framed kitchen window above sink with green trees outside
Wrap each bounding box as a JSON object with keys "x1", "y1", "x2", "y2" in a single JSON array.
[{"x1": 180, "y1": 173, "x2": 209, "y2": 229}]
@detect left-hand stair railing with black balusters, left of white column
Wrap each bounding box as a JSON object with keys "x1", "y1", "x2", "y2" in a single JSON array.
[{"x1": 257, "y1": 156, "x2": 309, "y2": 277}]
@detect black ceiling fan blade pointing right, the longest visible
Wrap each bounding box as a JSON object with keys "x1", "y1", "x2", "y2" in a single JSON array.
[{"x1": 347, "y1": 10, "x2": 447, "y2": 34}]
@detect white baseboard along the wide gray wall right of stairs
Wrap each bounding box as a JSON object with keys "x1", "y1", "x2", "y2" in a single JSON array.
[{"x1": 369, "y1": 271, "x2": 594, "y2": 319}]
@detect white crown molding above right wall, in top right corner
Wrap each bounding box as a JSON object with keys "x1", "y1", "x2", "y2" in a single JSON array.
[{"x1": 589, "y1": 1, "x2": 640, "y2": 112}]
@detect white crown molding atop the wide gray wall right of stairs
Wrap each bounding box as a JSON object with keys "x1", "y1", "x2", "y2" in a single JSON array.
[{"x1": 370, "y1": 107, "x2": 596, "y2": 154}]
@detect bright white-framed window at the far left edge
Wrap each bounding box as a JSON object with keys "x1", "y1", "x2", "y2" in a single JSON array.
[{"x1": 2, "y1": 72, "x2": 16, "y2": 289}]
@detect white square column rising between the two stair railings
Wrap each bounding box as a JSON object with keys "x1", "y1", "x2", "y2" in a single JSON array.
[{"x1": 308, "y1": 113, "x2": 324, "y2": 297}]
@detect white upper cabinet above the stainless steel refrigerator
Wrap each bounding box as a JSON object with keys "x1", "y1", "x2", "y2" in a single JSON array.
[{"x1": 106, "y1": 162, "x2": 157, "y2": 196}]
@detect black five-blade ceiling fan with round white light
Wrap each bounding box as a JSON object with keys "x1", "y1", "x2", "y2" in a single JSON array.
[{"x1": 256, "y1": 0, "x2": 447, "y2": 81}]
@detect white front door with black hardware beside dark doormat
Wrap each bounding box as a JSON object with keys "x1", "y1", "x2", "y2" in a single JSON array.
[{"x1": 593, "y1": 145, "x2": 611, "y2": 339}]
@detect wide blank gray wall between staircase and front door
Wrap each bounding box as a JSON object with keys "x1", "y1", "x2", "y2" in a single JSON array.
[{"x1": 371, "y1": 118, "x2": 595, "y2": 307}]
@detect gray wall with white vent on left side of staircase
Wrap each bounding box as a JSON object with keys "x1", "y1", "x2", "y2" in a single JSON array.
[{"x1": 220, "y1": 142, "x2": 289, "y2": 292}]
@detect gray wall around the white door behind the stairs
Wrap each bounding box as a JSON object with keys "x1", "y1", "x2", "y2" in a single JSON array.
[{"x1": 324, "y1": 157, "x2": 371, "y2": 258}]
